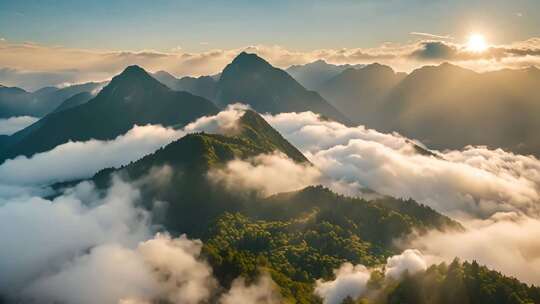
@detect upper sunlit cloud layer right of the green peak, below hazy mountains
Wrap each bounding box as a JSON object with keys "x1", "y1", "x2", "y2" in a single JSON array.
[{"x1": 266, "y1": 112, "x2": 540, "y2": 217}]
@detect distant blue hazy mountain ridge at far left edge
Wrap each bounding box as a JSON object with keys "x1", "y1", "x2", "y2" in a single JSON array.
[{"x1": 0, "y1": 82, "x2": 104, "y2": 118}]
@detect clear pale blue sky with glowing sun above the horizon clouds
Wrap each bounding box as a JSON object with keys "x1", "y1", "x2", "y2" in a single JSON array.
[{"x1": 0, "y1": 0, "x2": 540, "y2": 51}]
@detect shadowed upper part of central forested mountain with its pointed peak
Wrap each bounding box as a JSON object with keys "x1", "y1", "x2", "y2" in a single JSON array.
[{"x1": 83, "y1": 111, "x2": 309, "y2": 236}]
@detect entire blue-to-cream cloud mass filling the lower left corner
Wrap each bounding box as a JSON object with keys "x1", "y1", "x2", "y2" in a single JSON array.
[{"x1": 0, "y1": 178, "x2": 279, "y2": 304}]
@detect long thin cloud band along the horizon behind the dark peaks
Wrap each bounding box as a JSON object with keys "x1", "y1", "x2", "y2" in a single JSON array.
[{"x1": 0, "y1": 33, "x2": 540, "y2": 90}]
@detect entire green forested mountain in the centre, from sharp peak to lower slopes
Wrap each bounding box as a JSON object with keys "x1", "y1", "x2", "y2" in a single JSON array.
[{"x1": 81, "y1": 110, "x2": 462, "y2": 303}]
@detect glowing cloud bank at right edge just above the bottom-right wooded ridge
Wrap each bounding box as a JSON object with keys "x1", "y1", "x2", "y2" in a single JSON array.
[{"x1": 404, "y1": 213, "x2": 540, "y2": 286}]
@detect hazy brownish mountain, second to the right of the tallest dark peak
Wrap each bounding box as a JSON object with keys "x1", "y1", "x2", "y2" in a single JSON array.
[{"x1": 317, "y1": 63, "x2": 406, "y2": 126}]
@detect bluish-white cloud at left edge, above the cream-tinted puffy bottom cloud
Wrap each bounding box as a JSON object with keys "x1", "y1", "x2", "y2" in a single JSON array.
[{"x1": 0, "y1": 180, "x2": 149, "y2": 294}]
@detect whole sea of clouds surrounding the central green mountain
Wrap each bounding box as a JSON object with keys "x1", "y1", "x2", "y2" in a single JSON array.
[{"x1": 0, "y1": 105, "x2": 540, "y2": 304}]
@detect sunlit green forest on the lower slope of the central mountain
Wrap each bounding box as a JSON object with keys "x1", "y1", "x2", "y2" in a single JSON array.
[{"x1": 204, "y1": 186, "x2": 461, "y2": 303}]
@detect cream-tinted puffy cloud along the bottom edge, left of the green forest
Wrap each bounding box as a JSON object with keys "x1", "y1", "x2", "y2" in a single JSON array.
[{"x1": 23, "y1": 234, "x2": 216, "y2": 304}]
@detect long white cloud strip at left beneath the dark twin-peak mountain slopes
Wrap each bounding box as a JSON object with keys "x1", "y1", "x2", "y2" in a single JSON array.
[{"x1": 0, "y1": 125, "x2": 185, "y2": 185}]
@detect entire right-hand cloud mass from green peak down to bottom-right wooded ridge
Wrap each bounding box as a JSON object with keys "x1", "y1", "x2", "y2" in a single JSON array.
[{"x1": 266, "y1": 113, "x2": 540, "y2": 288}]
